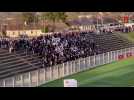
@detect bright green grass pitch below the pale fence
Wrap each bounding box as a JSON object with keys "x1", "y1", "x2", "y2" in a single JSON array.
[{"x1": 40, "y1": 57, "x2": 134, "y2": 87}]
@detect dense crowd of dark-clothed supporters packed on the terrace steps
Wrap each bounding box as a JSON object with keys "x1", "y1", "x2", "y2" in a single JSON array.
[{"x1": 0, "y1": 32, "x2": 98, "y2": 66}]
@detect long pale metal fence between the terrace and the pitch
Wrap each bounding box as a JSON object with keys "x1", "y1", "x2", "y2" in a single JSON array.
[{"x1": 0, "y1": 47, "x2": 134, "y2": 87}]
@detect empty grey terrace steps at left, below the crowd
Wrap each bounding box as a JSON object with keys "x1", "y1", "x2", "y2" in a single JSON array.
[{"x1": 0, "y1": 49, "x2": 42, "y2": 79}]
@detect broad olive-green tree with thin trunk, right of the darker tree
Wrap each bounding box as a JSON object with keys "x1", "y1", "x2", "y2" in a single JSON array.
[{"x1": 43, "y1": 12, "x2": 67, "y2": 31}]
